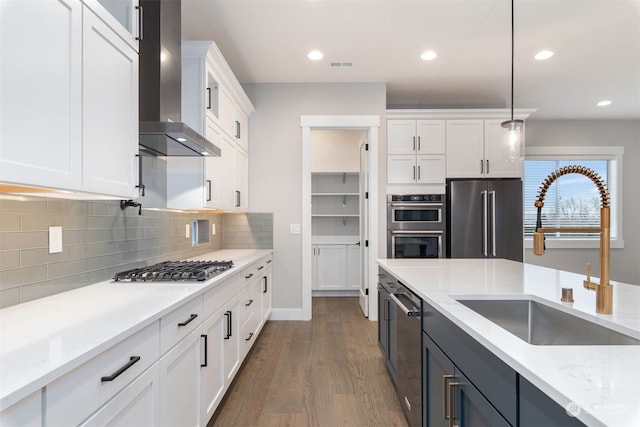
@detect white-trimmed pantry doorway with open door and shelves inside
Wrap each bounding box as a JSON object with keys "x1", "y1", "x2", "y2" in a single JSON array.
[{"x1": 300, "y1": 116, "x2": 380, "y2": 320}]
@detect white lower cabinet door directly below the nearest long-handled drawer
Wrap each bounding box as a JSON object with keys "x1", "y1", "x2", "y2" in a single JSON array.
[{"x1": 80, "y1": 362, "x2": 160, "y2": 427}]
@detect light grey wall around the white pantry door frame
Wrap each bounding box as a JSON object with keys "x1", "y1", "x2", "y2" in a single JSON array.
[{"x1": 244, "y1": 83, "x2": 386, "y2": 314}]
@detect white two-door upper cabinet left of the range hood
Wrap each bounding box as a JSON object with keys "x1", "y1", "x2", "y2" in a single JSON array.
[{"x1": 0, "y1": 0, "x2": 138, "y2": 198}]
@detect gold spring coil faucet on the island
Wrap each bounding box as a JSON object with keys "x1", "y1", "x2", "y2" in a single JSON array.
[{"x1": 533, "y1": 165, "x2": 613, "y2": 314}]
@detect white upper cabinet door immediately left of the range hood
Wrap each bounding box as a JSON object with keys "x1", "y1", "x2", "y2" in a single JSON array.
[{"x1": 82, "y1": 8, "x2": 138, "y2": 198}]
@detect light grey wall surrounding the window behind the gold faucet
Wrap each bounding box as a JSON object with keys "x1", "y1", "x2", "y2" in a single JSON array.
[{"x1": 525, "y1": 119, "x2": 640, "y2": 285}]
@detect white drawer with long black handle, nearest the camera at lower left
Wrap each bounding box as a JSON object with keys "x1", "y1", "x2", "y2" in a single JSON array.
[{"x1": 45, "y1": 322, "x2": 160, "y2": 427}]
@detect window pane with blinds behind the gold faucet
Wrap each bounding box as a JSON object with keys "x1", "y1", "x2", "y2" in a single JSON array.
[{"x1": 524, "y1": 160, "x2": 613, "y2": 239}]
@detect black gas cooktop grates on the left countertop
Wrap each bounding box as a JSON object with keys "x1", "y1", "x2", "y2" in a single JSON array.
[{"x1": 113, "y1": 261, "x2": 233, "y2": 282}]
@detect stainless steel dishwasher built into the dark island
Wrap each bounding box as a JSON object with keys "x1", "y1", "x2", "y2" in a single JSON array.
[{"x1": 389, "y1": 281, "x2": 422, "y2": 427}]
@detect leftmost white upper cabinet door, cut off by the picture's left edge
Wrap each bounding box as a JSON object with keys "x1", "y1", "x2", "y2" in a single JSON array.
[{"x1": 0, "y1": 0, "x2": 82, "y2": 190}]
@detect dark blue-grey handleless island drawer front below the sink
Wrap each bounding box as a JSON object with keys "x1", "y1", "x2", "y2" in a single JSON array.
[{"x1": 422, "y1": 301, "x2": 517, "y2": 425}]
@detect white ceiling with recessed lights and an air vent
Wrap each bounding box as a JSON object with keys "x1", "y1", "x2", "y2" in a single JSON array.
[{"x1": 182, "y1": 0, "x2": 640, "y2": 119}]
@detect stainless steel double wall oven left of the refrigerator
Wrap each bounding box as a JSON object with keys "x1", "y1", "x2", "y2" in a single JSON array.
[{"x1": 387, "y1": 194, "x2": 446, "y2": 258}]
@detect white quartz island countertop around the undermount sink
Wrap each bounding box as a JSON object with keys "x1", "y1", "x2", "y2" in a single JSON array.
[{"x1": 378, "y1": 259, "x2": 640, "y2": 427}]
